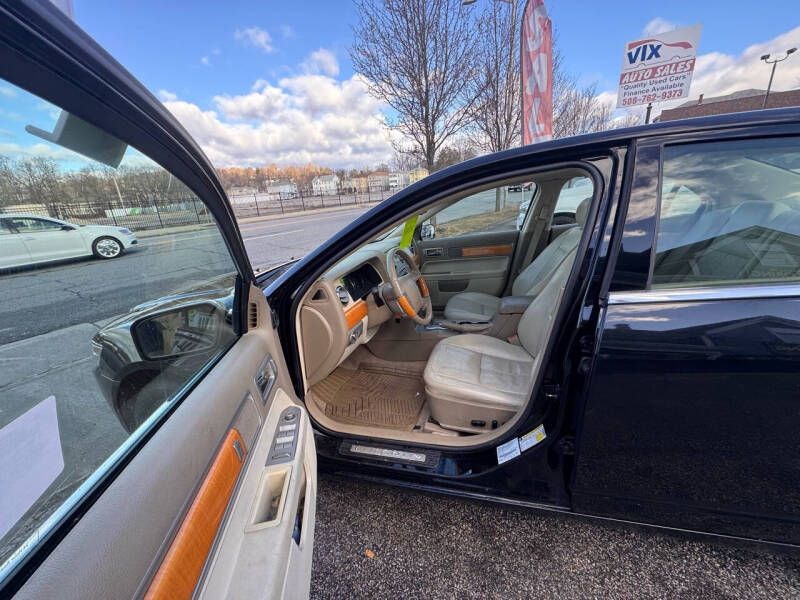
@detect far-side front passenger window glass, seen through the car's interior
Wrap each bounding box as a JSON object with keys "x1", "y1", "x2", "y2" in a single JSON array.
[{"x1": 421, "y1": 182, "x2": 536, "y2": 239}]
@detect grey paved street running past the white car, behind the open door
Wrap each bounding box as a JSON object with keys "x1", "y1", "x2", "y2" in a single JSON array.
[{"x1": 0, "y1": 208, "x2": 365, "y2": 345}]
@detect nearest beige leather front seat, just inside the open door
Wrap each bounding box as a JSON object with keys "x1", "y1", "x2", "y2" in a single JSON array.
[{"x1": 424, "y1": 250, "x2": 575, "y2": 432}]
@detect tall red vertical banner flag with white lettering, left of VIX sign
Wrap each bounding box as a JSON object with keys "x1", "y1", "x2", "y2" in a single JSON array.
[{"x1": 512, "y1": 0, "x2": 553, "y2": 145}]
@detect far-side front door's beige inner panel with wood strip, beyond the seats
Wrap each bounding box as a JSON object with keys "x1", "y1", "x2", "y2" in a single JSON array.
[{"x1": 417, "y1": 231, "x2": 519, "y2": 309}]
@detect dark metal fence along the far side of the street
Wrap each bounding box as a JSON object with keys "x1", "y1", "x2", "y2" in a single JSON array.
[{"x1": 0, "y1": 191, "x2": 392, "y2": 231}]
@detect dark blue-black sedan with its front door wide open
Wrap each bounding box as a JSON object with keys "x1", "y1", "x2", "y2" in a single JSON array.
[{"x1": 0, "y1": 4, "x2": 800, "y2": 597}]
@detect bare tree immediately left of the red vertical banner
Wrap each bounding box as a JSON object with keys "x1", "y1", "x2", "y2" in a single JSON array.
[{"x1": 471, "y1": 0, "x2": 522, "y2": 152}]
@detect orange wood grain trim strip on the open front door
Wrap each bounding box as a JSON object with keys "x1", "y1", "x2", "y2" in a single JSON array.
[{"x1": 144, "y1": 429, "x2": 247, "y2": 600}]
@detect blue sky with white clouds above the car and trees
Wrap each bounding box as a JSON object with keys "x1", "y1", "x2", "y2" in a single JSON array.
[{"x1": 0, "y1": 0, "x2": 800, "y2": 167}]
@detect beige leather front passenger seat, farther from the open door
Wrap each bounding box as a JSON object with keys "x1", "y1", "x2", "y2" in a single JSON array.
[{"x1": 444, "y1": 198, "x2": 591, "y2": 321}]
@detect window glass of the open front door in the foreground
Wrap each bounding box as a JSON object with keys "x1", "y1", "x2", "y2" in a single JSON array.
[{"x1": 0, "y1": 81, "x2": 237, "y2": 577}]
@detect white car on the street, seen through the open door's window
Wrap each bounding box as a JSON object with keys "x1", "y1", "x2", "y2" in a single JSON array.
[{"x1": 0, "y1": 214, "x2": 138, "y2": 269}]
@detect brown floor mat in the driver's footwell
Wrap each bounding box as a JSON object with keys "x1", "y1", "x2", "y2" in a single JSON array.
[{"x1": 311, "y1": 367, "x2": 425, "y2": 429}]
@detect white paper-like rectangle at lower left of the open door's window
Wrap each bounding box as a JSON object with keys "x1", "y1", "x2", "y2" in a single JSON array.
[{"x1": 0, "y1": 396, "x2": 64, "y2": 537}]
